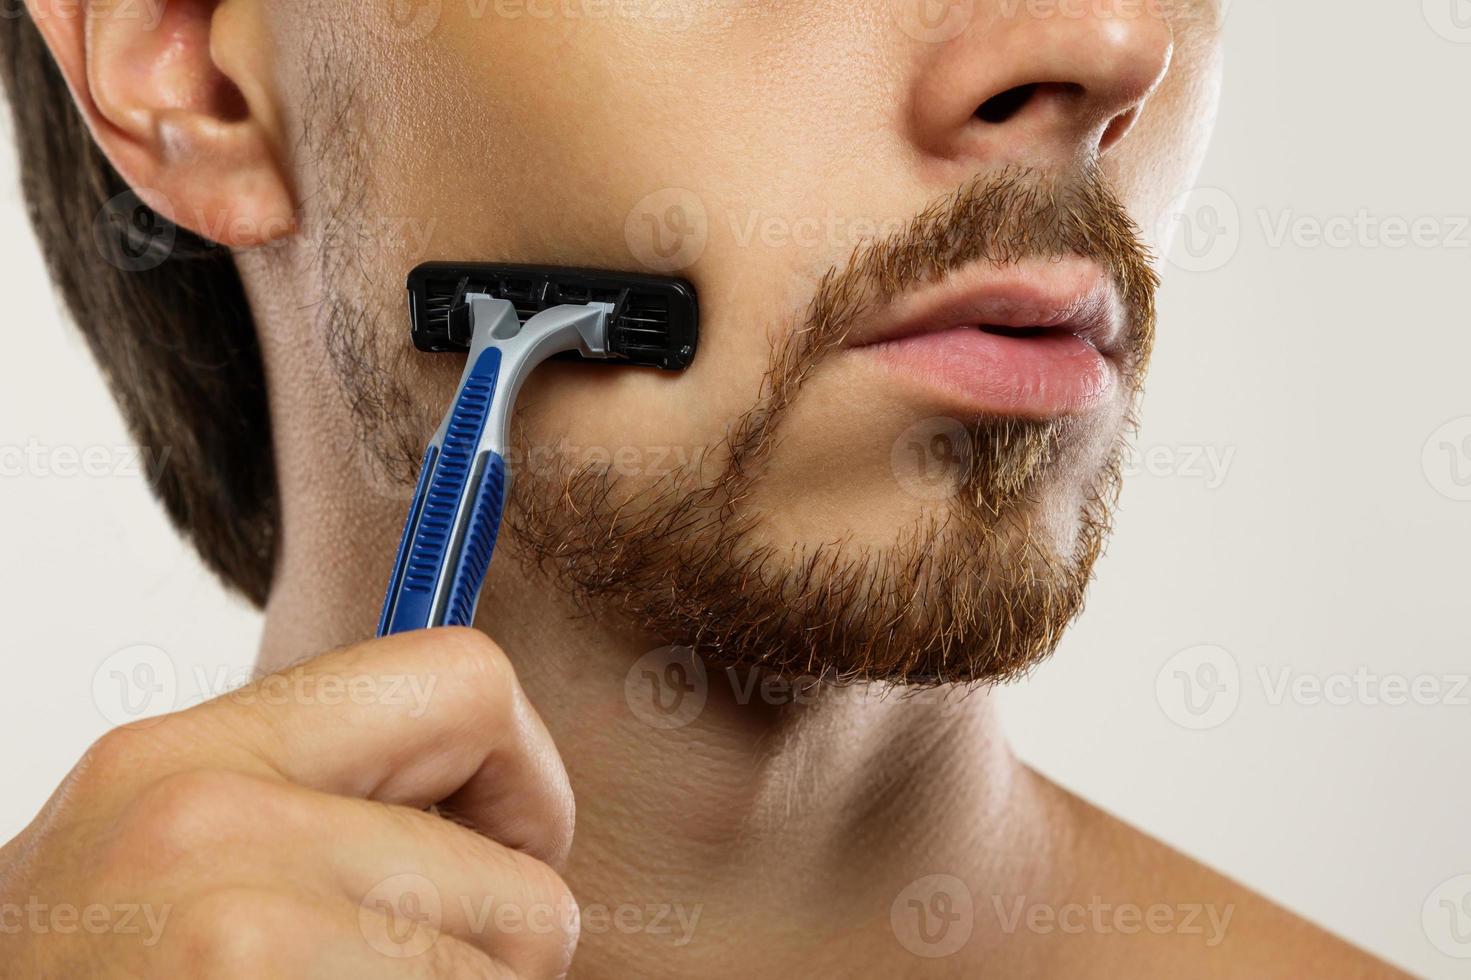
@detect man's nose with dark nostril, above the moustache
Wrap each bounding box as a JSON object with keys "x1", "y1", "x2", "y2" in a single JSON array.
[{"x1": 911, "y1": 0, "x2": 1174, "y2": 168}]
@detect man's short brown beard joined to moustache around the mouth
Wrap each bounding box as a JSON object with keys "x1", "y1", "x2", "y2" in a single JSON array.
[{"x1": 506, "y1": 169, "x2": 1156, "y2": 684}]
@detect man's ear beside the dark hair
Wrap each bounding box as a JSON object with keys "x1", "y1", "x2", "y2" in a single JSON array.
[{"x1": 26, "y1": 0, "x2": 294, "y2": 247}]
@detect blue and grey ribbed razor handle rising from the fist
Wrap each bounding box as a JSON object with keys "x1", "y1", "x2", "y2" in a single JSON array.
[{"x1": 378, "y1": 294, "x2": 612, "y2": 636}]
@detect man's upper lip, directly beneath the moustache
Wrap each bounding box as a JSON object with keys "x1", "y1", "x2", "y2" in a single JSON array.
[{"x1": 846, "y1": 256, "x2": 1125, "y2": 355}]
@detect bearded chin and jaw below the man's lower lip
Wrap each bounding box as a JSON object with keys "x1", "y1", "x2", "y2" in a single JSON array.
[{"x1": 509, "y1": 400, "x2": 1121, "y2": 684}]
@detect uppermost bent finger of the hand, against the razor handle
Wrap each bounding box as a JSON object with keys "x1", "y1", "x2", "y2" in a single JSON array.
[{"x1": 137, "y1": 630, "x2": 574, "y2": 867}]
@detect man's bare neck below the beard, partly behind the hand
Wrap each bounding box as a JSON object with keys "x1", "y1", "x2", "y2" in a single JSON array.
[{"x1": 262, "y1": 528, "x2": 1041, "y2": 977}]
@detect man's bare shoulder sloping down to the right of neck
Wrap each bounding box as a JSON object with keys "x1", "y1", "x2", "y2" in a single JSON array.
[{"x1": 964, "y1": 777, "x2": 1409, "y2": 980}]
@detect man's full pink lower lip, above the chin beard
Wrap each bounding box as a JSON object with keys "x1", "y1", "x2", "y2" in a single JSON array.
[{"x1": 852, "y1": 327, "x2": 1116, "y2": 418}]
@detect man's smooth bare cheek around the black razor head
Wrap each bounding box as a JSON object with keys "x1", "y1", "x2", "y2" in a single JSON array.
[{"x1": 326, "y1": 0, "x2": 922, "y2": 468}]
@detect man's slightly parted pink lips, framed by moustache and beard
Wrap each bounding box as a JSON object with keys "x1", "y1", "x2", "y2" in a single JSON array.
[{"x1": 844, "y1": 258, "x2": 1127, "y2": 419}]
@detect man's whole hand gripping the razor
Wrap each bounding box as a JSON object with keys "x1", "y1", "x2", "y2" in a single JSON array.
[{"x1": 0, "y1": 630, "x2": 577, "y2": 980}]
